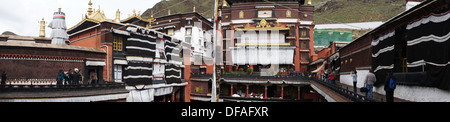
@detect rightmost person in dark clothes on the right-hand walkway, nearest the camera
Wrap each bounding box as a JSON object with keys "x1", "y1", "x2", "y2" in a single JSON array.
[{"x1": 384, "y1": 72, "x2": 397, "y2": 102}]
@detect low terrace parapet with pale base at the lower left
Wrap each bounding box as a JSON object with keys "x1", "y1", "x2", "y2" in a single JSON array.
[{"x1": 0, "y1": 83, "x2": 129, "y2": 102}]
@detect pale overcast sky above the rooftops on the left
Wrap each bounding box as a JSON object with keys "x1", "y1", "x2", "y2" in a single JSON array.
[{"x1": 0, "y1": 0, "x2": 161, "y2": 37}]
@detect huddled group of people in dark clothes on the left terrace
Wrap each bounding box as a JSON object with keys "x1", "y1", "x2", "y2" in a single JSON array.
[{"x1": 56, "y1": 68, "x2": 83, "y2": 85}]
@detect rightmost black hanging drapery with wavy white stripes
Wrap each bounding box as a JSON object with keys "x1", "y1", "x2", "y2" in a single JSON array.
[{"x1": 406, "y1": 11, "x2": 450, "y2": 90}]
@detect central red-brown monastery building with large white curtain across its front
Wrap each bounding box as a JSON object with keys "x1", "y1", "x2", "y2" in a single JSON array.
[{"x1": 220, "y1": 0, "x2": 314, "y2": 72}]
